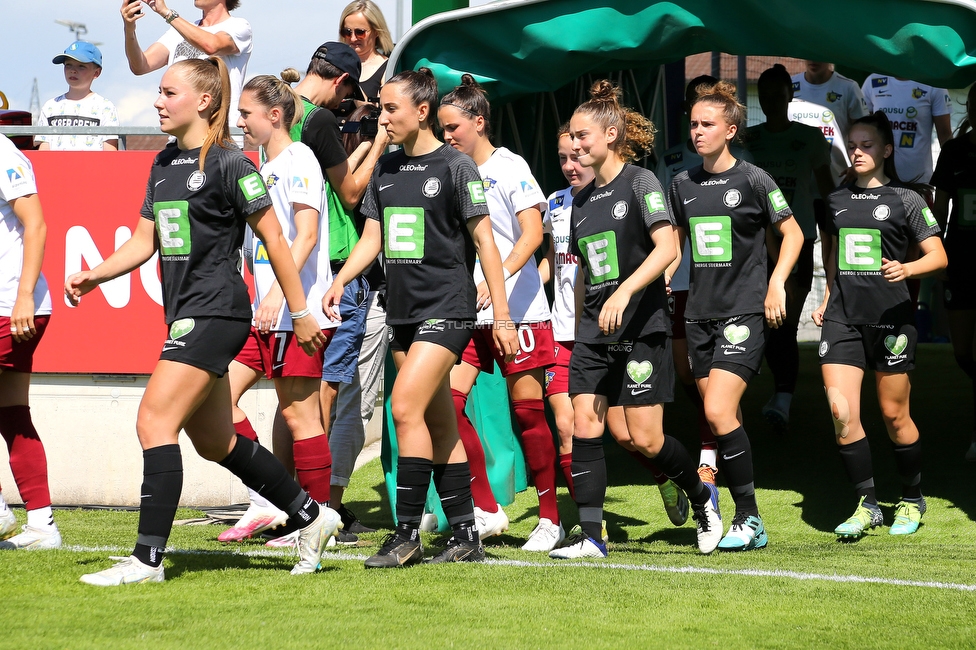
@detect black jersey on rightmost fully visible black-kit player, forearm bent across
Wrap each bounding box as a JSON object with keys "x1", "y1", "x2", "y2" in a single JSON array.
[{"x1": 824, "y1": 184, "x2": 939, "y2": 325}]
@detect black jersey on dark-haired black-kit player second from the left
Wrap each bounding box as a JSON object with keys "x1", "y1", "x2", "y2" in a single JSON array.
[{"x1": 361, "y1": 145, "x2": 488, "y2": 325}]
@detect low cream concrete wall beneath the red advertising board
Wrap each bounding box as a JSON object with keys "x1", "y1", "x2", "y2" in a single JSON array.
[{"x1": 0, "y1": 374, "x2": 382, "y2": 506}]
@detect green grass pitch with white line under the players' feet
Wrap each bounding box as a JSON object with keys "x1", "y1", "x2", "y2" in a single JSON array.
[{"x1": 0, "y1": 346, "x2": 976, "y2": 648}]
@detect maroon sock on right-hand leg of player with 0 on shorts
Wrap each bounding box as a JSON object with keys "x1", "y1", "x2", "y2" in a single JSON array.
[{"x1": 512, "y1": 399, "x2": 559, "y2": 524}]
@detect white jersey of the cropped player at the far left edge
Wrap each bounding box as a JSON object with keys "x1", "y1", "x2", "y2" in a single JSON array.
[{"x1": 0, "y1": 135, "x2": 51, "y2": 318}]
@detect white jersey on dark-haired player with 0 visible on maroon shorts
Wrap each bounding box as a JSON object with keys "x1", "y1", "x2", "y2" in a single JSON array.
[{"x1": 474, "y1": 147, "x2": 551, "y2": 323}]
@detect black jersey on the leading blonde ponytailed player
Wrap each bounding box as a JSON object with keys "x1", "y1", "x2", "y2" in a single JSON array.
[{"x1": 142, "y1": 142, "x2": 271, "y2": 324}]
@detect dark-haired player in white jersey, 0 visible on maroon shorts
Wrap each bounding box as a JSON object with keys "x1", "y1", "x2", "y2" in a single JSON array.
[{"x1": 437, "y1": 74, "x2": 565, "y2": 551}]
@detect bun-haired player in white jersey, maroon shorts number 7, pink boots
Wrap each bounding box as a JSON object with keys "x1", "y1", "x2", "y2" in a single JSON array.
[{"x1": 217, "y1": 71, "x2": 338, "y2": 542}]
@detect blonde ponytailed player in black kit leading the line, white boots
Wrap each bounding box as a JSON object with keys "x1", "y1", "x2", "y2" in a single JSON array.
[{"x1": 64, "y1": 57, "x2": 339, "y2": 587}]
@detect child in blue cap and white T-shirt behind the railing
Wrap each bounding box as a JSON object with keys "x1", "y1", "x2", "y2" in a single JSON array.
[{"x1": 34, "y1": 41, "x2": 119, "y2": 151}]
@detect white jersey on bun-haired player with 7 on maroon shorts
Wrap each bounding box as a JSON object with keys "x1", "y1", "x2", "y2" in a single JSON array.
[{"x1": 248, "y1": 142, "x2": 338, "y2": 332}]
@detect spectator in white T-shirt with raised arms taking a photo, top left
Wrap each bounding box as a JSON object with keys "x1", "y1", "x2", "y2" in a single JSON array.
[{"x1": 122, "y1": 0, "x2": 251, "y2": 121}]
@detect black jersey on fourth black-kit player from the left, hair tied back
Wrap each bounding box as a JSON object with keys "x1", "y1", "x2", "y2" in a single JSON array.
[{"x1": 668, "y1": 160, "x2": 793, "y2": 320}]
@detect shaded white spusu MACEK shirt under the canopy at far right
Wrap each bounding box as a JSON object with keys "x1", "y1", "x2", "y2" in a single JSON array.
[{"x1": 861, "y1": 74, "x2": 952, "y2": 183}]
